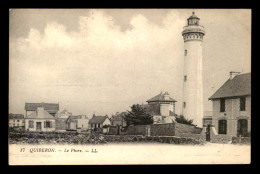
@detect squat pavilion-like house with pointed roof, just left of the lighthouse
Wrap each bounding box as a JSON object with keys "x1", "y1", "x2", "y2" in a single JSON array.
[{"x1": 145, "y1": 92, "x2": 177, "y2": 124}]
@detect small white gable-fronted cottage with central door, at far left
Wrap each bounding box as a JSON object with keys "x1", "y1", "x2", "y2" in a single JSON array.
[{"x1": 25, "y1": 107, "x2": 55, "y2": 132}]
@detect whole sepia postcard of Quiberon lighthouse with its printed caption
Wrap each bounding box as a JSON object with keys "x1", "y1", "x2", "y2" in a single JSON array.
[{"x1": 8, "y1": 8, "x2": 252, "y2": 165}]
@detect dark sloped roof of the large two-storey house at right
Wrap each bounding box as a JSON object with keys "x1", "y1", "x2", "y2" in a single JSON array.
[{"x1": 209, "y1": 73, "x2": 251, "y2": 100}]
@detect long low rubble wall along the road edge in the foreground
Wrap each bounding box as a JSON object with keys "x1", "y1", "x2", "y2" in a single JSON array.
[{"x1": 9, "y1": 132, "x2": 204, "y2": 144}]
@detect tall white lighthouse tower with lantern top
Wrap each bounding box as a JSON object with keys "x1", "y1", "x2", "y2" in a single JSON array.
[{"x1": 182, "y1": 12, "x2": 205, "y2": 127}]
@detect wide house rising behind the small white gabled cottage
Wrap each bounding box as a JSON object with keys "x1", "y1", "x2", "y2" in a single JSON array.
[{"x1": 25, "y1": 102, "x2": 59, "y2": 117}]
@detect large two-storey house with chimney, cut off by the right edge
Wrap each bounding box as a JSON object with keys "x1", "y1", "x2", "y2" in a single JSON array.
[{"x1": 209, "y1": 72, "x2": 251, "y2": 136}]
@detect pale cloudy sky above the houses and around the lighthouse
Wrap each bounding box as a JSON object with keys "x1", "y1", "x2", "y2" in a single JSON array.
[{"x1": 9, "y1": 9, "x2": 251, "y2": 116}]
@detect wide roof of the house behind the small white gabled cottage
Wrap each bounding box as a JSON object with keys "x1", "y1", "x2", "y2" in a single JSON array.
[{"x1": 25, "y1": 103, "x2": 59, "y2": 111}]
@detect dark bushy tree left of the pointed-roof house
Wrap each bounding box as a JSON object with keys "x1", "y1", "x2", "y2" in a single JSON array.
[{"x1": 123, "y1": 104, "x2": 153, "y2": 126}]
